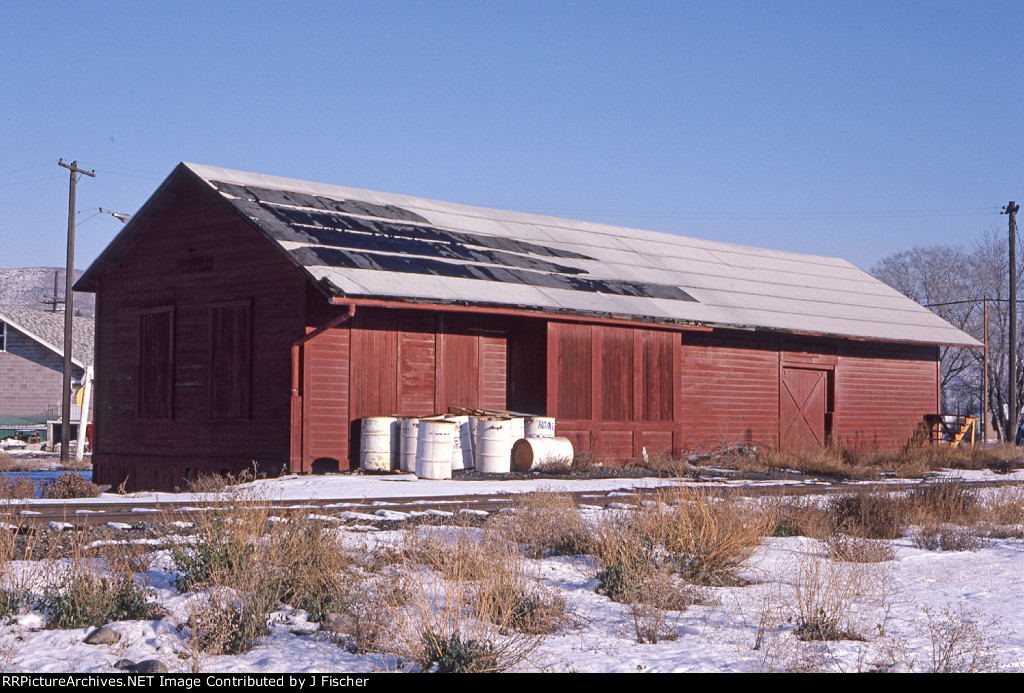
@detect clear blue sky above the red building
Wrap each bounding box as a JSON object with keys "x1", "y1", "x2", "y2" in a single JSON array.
[{"x1": 0, "y1": 0, "x2": 1024, "y2": 269}]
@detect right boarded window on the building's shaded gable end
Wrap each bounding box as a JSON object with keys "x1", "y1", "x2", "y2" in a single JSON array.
[{"x1": 210, "y1": 302, "x2": 252, "y2": 419}]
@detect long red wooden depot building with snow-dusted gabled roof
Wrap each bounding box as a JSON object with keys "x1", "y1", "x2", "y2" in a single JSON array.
[{"x1": 76, "y1": 164, "x2": 977, "y2": 489}]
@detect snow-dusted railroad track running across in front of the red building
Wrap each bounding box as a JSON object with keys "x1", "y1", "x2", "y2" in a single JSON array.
[{"x1": 0, "y1": 479, "x2": 1019, "y2": 529}]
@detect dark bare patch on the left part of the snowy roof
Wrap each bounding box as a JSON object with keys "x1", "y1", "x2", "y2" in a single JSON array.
[{"x1": 211, "y1": 181, "x2": 695, "y2": 301}]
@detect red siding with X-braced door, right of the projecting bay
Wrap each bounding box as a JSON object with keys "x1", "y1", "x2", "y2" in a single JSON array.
[{"x1": 682, "y1": 331, "x2": 939, "y2": 450}]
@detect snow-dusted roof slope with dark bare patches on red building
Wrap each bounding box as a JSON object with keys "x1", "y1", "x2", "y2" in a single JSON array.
[{"x1": 159, "y1": 164, "x2": 980, "y2": 346}]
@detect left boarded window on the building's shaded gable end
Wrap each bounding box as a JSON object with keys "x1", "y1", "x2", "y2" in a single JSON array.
[{"x1": 138, "y1": 308, "x2": 174, "y2": 419}]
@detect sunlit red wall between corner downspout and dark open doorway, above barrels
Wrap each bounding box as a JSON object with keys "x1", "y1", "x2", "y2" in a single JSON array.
[{"x1": 300, "y1": 307, "x2": 508, "y2": 470}]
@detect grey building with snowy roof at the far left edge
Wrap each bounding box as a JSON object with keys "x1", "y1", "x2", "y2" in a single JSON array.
[{"x1": 0, "y1": 306, "x2": 94, "y2": 437}]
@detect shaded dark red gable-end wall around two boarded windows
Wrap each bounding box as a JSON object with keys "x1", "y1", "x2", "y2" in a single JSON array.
[{"x1": 93, "y1": 172, "x2": 306, "y2": 489}]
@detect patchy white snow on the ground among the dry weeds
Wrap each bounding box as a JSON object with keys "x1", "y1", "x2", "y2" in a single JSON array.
[{"x1": 0, "y1": 474, "x2": 1024, "y2": 673}]
